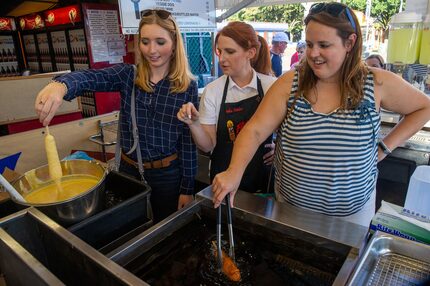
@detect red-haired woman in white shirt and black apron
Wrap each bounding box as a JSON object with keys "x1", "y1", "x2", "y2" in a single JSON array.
[{"x1": 178, "y1": 22, "x2": 276, "y2": 192}]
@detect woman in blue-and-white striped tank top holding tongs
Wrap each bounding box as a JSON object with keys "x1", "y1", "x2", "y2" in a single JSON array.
[{"x1": 213, "y1": 2, "x2": 430, "y2": 226}]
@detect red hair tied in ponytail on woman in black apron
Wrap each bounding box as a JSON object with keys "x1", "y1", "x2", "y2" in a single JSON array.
[{"x1": 215, "y1": 21, "x2": 272, "y2": 75}]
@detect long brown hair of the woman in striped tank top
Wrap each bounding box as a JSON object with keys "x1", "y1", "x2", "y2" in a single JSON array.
[{"x1": 295, "y1": 2, "x2": 368, "y2": 109}]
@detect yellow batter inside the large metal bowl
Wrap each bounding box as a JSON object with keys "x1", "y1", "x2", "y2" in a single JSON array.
[{"x1": 24, "y1": 175, "x2": 99, "y2": 204}]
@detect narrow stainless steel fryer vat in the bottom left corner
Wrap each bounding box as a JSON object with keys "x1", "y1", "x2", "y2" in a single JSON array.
[{"x1": 0, "y1": 207, "x2": 147, "y2": 286}]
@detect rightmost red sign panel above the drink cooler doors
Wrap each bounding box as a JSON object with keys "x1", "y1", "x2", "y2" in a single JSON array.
[{"x1": 43, "y1": 5, "x2": 82, "y2": 27}]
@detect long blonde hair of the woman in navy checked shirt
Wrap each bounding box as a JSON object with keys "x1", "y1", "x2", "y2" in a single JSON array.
[{"x1": 135, "y1": 10, "x2": 194, "y2": 93}]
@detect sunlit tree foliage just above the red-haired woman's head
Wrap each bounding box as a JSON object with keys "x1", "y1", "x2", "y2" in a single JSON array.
[{"x1": 229, "y1": 4, "x2": 305, "y2": 40}]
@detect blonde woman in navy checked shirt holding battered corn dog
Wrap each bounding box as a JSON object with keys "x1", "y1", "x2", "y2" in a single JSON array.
[{"x1": 35, "y1": 9, "x2": 198, "y2": 222}]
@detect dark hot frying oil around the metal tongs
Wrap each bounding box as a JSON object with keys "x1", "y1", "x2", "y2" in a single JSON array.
[{"x1": 125, "y1": 219, "x2": 342, "y2": 286}]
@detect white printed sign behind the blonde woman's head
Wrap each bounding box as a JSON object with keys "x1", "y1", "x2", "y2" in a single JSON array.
[{"x1": 118, "y1": 0, "x2": 216, "y2": 34}]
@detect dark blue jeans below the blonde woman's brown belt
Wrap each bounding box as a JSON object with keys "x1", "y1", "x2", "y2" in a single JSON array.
[{"x1": 119, "y1": 159, "x2": 182, "y2": 224}]
